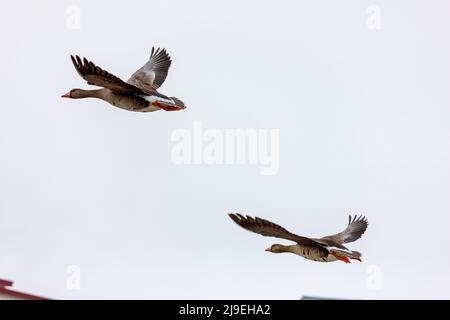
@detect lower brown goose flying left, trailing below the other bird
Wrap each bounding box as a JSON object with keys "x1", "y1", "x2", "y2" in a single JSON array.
[{"x1": 229, "y1": 213, "x2": 368, "y2": 263}]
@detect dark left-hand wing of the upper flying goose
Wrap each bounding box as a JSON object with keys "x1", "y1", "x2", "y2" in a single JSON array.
[{"x1": 70, "y1": 55, "x2": 145, "y2": 94}]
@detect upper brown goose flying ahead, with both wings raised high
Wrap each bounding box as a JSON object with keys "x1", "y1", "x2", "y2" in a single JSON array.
[{"x1": 62, "y1": 48, "x2": 186, "y2": 112}]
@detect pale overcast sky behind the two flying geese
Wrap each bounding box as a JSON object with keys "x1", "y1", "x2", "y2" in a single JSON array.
[{"x1": 0, "y1": 0, "x2": 450, "y2": 299}]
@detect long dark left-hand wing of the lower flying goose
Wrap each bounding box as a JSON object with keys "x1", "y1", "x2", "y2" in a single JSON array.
[{"x1": 229, "y1": 213, "x2": 319, "y2": 245}]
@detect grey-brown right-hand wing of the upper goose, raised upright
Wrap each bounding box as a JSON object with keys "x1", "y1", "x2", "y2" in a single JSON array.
[{"x1": 127, "y1": 47, "x2": 172, "y2": 91}]
